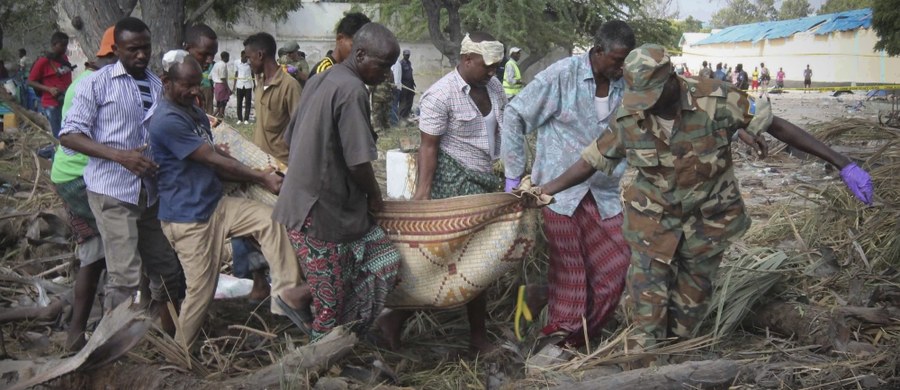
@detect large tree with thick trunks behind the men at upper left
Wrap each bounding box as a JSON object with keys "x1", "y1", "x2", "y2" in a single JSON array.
[{"x1": 59, "y1": 0, "x2": 301, "y2": 65}]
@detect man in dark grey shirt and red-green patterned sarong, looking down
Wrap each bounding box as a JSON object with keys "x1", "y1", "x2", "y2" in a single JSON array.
[{"x1": 274, "y1": 23, "x2": 400, "y2": 341}]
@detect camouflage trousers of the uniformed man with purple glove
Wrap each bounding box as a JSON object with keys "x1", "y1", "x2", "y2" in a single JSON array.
[{"x1": 625, "y1": 237, "x2": 727, "y2": 352}]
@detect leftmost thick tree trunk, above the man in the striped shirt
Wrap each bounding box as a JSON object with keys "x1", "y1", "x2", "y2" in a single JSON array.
[{"x1": 59, "y1": 0, "x2": 137, "y2": 60}]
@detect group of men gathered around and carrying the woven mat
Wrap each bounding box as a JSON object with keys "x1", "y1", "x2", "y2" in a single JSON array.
[{"x1": 24, "y1": 13, "x2": 872, "y2": 365}]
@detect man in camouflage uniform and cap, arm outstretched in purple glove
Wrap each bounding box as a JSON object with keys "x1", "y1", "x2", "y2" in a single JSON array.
[{"x1": 543, "y1": 44, "x2": 872, "y2": 364}]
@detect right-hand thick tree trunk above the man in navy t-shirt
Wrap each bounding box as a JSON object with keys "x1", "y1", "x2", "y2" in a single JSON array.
[{"x1": 141, "y1": 0, "x2": 184, "y2": 72}]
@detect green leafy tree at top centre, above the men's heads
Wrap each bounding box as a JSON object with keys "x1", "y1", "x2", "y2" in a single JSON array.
[{"x1": 367, "y1": 0, "x2": 674, "y2": 71}]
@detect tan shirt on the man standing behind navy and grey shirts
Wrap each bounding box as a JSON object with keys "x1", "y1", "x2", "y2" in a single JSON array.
[{"x1": 253, "y1": 71, "x2": 301, "y2": 164}]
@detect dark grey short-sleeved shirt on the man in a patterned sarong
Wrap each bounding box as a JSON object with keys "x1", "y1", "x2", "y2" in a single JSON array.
[{"x1": 273, "y1": 61, "x2": 378, "y2": 243}]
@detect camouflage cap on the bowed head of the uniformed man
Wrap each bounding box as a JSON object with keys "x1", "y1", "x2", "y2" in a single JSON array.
[{"x1": 622, "y1": 43, "x2": 675, "y2": 111}]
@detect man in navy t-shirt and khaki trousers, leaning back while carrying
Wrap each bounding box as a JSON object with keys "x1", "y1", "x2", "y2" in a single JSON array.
[{"x1": 149, "y1": 50, "x2": 309, "y2": 347}]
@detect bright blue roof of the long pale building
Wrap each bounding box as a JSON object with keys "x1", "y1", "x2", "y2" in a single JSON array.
[{"x1": 694, "y1": 8, "x2": 872, "y2": 45}]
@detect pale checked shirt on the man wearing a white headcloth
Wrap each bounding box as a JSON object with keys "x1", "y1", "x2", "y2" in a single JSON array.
[{"x1": 419, "y1": 69, "x2": 506, "y2": 172}]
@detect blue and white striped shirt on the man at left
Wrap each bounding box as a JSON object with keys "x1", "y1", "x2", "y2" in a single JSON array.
[{"x1": 59, "y1": 62, "x2": 162, "y2": 206}]
